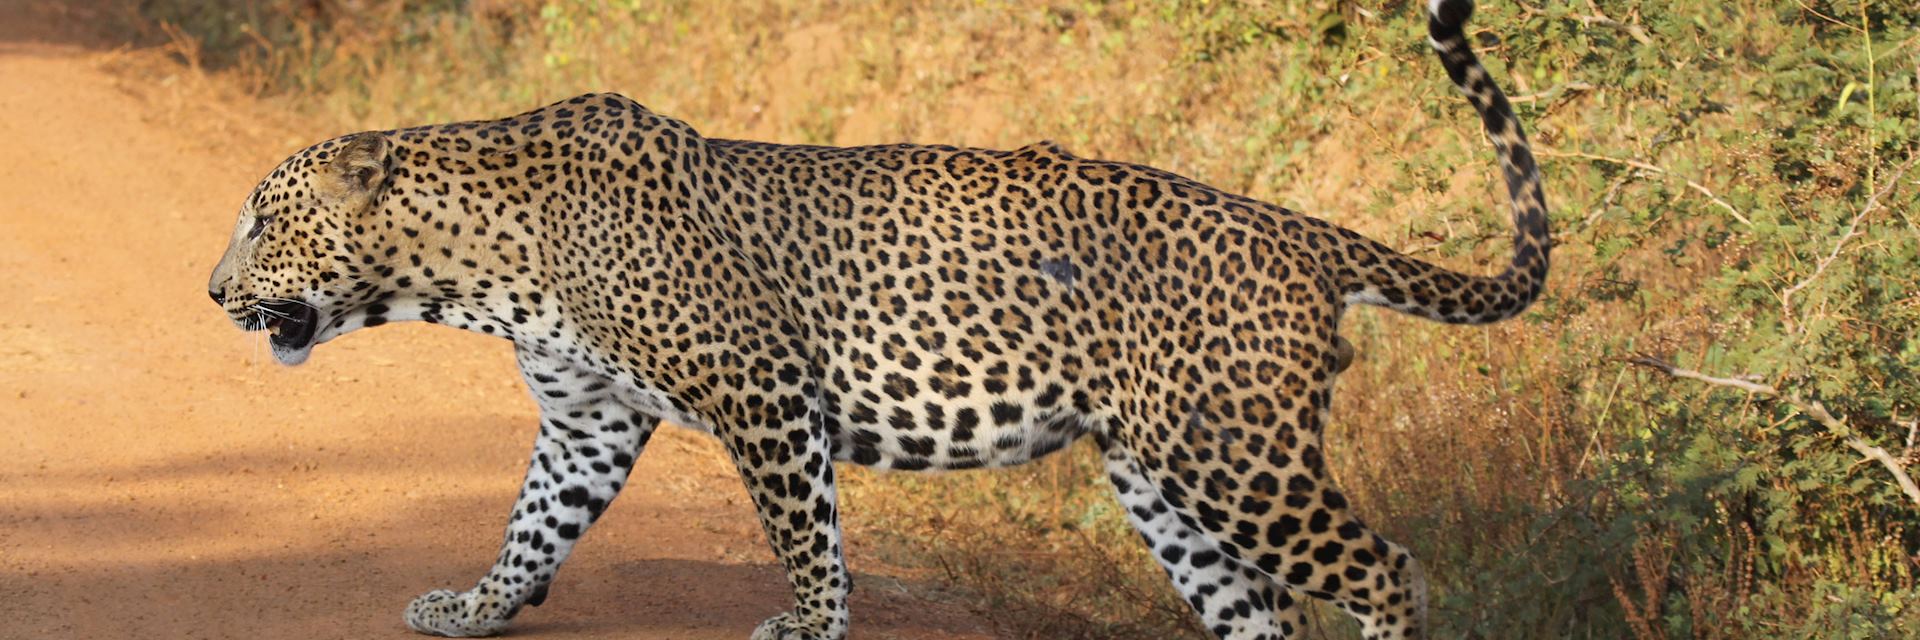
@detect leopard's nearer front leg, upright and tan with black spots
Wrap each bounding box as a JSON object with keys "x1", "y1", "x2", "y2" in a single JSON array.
[{"x1": 724, "y1": 398, "x2": 852, "y2": 640}]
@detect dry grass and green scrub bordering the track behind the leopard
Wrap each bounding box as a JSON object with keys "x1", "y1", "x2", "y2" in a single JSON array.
[{"x1": 123, "y1": 0, "x2": 1920, "y2": 638}]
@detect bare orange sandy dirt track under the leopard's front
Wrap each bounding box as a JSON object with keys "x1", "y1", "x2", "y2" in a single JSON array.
[{"x1": 0, "y1": 0, "x2": 993, "y2": 638}]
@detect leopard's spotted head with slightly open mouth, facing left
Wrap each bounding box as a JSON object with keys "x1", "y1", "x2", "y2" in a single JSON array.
[{"x1": 207, "y1": 133, "x2": 392, "y2": 365}]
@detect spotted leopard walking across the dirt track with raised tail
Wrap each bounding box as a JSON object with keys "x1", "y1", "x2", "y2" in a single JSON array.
[{"x1": 207, "y1": 0, "x2": 1551, "y2": 640}]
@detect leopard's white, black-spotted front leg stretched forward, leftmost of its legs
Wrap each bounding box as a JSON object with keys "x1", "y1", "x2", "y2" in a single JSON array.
[{"x1": 405, "y1": 350, "x2": 659, "y2": 638}]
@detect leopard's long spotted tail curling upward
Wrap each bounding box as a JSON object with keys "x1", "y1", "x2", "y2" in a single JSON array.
[{"x1": 1340, "y1": 0, "x2": 1551, "y2": 325}]
